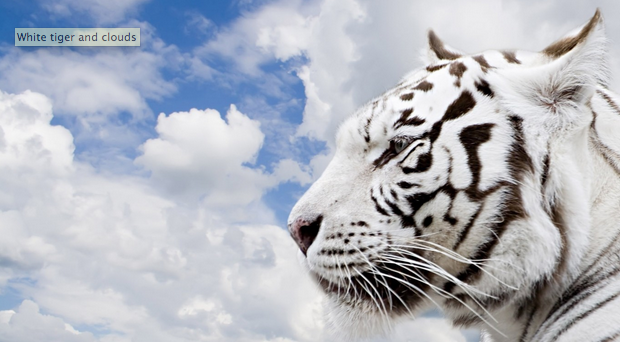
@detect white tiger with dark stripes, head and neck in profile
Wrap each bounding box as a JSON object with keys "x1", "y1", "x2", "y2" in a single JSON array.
[{"x1": 289, "y1": 11, "x2": 620, "y2": 341}]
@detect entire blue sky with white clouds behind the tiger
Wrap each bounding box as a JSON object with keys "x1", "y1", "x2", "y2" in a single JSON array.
[{"x1": 0, "y1": 0, "x2": 620, "y2": 342}]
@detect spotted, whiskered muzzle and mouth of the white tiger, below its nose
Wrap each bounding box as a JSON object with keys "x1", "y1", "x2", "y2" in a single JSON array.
[{"x1": 307, "y1": 230, "x2": 429, "y2": 313}]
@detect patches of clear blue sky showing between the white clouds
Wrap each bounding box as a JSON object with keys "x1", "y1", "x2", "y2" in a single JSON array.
[{"x1": 0, "y1": 1, "x2": 318, "y2": 225}]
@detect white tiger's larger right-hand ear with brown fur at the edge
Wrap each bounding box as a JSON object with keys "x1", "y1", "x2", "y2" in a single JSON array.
[{"x1": 498, "y1": 10, "x2": 609, "y2": 121}]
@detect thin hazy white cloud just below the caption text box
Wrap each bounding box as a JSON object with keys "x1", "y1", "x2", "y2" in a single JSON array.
[{"x1": 0, "y1": 48, "x2": 176, "y2": 125}]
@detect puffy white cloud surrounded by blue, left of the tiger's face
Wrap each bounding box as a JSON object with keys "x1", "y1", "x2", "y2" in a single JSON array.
[{"x1": 136, "y1": 105, "x2": 310, "y2": 207}]
